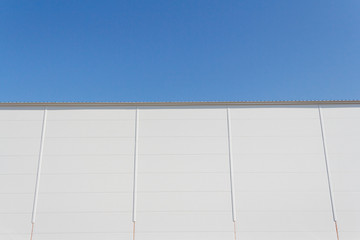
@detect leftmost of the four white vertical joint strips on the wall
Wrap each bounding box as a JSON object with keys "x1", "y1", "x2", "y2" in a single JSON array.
[{"x1": 31, "y1": 107, "x2": 47, "y2": 225}]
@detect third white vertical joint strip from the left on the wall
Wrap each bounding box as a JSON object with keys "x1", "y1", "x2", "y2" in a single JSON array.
[{"x1": 226, "y1": 108, "x2": 236, "y2": 223}]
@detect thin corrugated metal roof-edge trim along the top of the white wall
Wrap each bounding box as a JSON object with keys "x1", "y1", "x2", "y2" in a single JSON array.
[{"x1": 0, "y1": 100, "x2": 360, "y2": 107}]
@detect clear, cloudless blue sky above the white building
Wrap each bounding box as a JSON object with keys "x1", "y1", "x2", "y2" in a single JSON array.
[{"x1": 0, "y1": 0, "x2": 360, "y2": 101}]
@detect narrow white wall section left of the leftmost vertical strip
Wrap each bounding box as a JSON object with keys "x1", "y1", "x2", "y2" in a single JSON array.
[{"x1": 0, "y1": 108, "x2": 43, "y2": 240}]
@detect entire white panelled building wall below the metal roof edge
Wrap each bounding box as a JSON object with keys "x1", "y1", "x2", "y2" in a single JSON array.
[{"x1": 0, "y1": 104, "x2": 360, "y2": 240}]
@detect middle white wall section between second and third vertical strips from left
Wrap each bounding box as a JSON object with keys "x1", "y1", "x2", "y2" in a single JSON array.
[{"x1": 136, "y1": 108, "x2": 234, "y2": 240}]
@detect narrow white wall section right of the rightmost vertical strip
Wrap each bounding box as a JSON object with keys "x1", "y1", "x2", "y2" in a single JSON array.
[{"x1": 322, "y1": 105, "x2": 360, "y2": 240}]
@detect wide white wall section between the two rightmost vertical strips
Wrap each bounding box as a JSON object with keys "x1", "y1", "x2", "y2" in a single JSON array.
[{"x1": 231, "y1": 106, "x2": 336, "y2": 240}]
